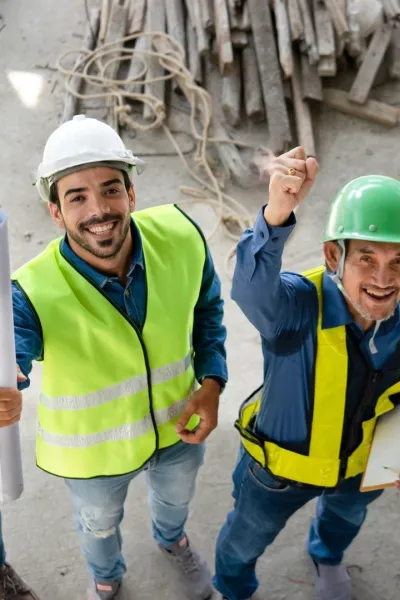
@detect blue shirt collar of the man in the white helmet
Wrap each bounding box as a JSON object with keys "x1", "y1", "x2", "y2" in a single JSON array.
[{"x1": 60, "y1": 218, "x2": 144, "y2": 288}]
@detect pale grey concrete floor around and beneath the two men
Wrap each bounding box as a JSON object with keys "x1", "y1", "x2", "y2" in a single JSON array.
[{"x1": 0, "y1": 0, "x2": 400, "y2": 600}]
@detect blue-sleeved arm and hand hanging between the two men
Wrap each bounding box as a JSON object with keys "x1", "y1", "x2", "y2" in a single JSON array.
[{"x1": 176, "y1": 248, "x2": 228, "y2": 444}]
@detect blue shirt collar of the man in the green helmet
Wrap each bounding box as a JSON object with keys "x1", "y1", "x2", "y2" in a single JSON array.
[{"x1": 322, "y1": 272, "x2": 400, "y2": 331}]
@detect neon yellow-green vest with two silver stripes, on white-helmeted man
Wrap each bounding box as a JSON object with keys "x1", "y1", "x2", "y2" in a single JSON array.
[{"x1": 14, "y1": 205, "x2": 206, "y2": 479}]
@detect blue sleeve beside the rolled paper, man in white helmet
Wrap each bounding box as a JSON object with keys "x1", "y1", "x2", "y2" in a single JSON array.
[{"x1": 12, "y1": 282, "x2": 43, "y2": 390}]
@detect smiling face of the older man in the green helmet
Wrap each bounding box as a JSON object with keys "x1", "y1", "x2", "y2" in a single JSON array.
[{"x1": 324, "y1": 240, "x2": 400, "y2": 326}]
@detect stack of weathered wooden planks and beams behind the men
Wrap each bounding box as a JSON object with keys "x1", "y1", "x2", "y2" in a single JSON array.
[{"x1": 62, "y1": 0, "x2": 400, "y2": 155}]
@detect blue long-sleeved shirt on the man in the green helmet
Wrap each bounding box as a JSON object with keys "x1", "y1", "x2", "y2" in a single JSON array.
[{"x1": 231, "y1": 210, "x2": 400, "y2": 447}]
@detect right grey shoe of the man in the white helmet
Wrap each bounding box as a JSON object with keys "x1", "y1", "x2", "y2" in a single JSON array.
[{"x1": 160, "y1": 536, "x2": 214, "y2": 600}]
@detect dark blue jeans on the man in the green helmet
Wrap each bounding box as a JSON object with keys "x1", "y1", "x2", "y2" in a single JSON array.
[{"x1": 214, "y1": 448, "x2": 382, "y2": 600}]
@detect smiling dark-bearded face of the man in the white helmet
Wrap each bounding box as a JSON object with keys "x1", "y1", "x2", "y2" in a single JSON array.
[{"x1": 49, "y1": 167, "x2": 135, "y2": 264}]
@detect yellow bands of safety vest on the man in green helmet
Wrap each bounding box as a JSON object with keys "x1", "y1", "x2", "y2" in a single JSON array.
[{"x1": 235, "y1": 267, "x2": 400, "y2": 487}]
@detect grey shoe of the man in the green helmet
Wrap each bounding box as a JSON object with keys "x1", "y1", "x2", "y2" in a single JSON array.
[{"x1": 315, "y1": 564, "x2": 354, "y2": 600}]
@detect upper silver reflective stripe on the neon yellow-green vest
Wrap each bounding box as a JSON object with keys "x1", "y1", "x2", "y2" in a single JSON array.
[{"x1": 39, "y1": 352, "x2": 192, "y2": 410}]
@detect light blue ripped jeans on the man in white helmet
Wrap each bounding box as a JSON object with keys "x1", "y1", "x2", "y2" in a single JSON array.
[{"x1": 66, "y1": 442, "x2": 205, "y2": 582}]
